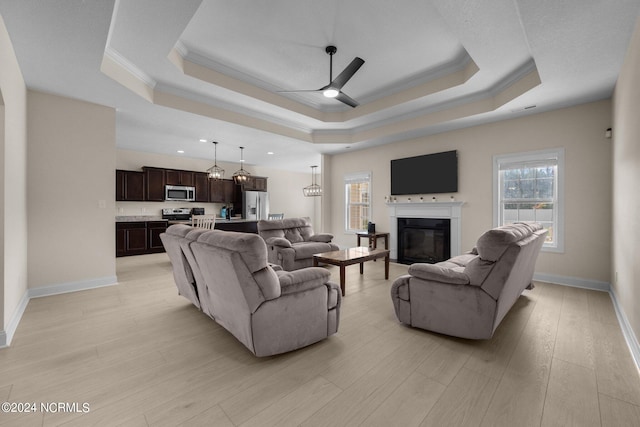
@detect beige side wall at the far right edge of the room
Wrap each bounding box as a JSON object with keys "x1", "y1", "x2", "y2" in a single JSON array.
[{"x1": 611, "y1": 19, "x2": 640, "y2": 348}]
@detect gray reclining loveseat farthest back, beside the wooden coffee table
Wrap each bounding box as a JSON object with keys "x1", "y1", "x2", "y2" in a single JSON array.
[{"x1": 258, "y1": 218, "x2": 339, "y2": 271}]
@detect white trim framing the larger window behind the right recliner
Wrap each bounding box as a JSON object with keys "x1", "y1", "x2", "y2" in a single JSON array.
[{"x1": 493, "y1": 148, "x2": 565, "y2": 253}]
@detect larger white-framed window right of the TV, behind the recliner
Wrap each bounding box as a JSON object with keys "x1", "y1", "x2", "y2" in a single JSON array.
[{"x1": 493, "y1": 148, "x2": 564, "y2": 252}]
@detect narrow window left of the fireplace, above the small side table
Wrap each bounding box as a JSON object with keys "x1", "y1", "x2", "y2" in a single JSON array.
[{"x1": 344, "y1": 172, "x2": 371, "y2": 232}]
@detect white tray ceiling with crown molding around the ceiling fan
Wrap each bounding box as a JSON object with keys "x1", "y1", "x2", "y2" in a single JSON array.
[{"x1": 0, "y1": 0, "x2": 640, "y2": 172}]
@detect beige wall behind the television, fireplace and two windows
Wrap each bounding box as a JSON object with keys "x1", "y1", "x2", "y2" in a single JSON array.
[{"x1": 330, "y1": 100, "x2": 611, "y2": 283}]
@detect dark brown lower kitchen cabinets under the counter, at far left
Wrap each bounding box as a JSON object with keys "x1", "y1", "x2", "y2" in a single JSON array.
[{"x1": 116, "y1": 221, "x2": 167, "y2": 257}]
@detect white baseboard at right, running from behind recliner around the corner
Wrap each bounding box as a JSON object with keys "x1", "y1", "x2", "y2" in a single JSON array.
[{"x1": 533, "y1": 273, "x2": 640, "y2": 371}]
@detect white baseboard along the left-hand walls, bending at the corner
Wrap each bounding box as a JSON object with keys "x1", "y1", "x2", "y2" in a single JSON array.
[{"x1": 0, "y1": 276, "x2": 118, "y2": 348}]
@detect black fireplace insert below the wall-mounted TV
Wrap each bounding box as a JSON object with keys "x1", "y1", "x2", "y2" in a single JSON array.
[{"x1": 398, "y1": 218, "x2": 451, "y2": 264}]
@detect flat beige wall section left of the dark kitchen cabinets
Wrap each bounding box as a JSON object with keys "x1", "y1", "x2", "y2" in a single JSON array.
[{"x1": 27, "y1": 91, "x2": 115, "y2": 288}]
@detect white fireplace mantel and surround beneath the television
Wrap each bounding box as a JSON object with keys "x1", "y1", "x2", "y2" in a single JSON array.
[{"x1": 387, "y1": 202, "x2": 464, "y2": 259}]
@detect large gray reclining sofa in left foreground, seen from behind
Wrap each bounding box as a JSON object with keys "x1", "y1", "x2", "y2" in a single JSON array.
[{"x1": 161, "y1": 225, "x2": 342, "y2": 356}]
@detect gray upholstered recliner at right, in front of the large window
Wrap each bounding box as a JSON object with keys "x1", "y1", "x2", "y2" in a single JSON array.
[{"x1": 391, "y1": 222, "x2": 547, "y2": 339}]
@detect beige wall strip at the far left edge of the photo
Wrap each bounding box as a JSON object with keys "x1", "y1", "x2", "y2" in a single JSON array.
[{"x1": 0, "y1": 17, "x2": 27, "y2": 338}]
